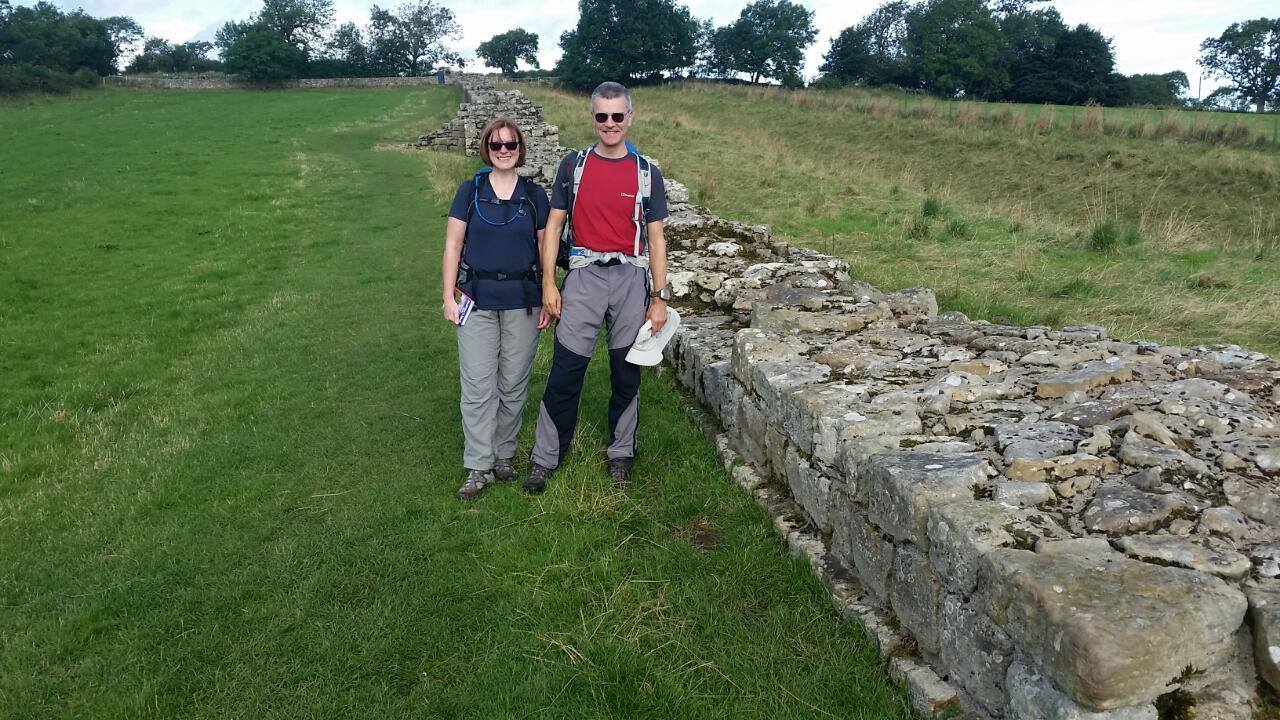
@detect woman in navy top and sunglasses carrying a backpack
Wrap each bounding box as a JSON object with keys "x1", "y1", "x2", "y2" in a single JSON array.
[{"x1": 443, "y1": 118, "x2": 548, "y2": 500}]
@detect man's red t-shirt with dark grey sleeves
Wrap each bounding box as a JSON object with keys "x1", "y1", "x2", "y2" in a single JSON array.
[{"x1": 552, "y1": 151, "x2": 668, "y2": 255}]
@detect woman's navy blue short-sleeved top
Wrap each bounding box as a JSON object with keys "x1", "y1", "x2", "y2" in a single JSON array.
[{"x1": 449, "y1": 174, "x2": 550, "y2": 310}]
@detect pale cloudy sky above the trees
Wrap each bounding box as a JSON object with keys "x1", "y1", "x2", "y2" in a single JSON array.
[{"x1": 35, "y1": 0, "x2": 1277, "y2": 94}]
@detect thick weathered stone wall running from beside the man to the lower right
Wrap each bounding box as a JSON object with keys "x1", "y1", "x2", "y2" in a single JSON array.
[{"x1": 422, "y1": 75, "x2": 1280, "y2": 720}]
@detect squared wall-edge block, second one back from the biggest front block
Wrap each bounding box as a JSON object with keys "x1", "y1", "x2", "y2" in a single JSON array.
[{"x1": 856, "y1": 452, "x2": 989, "y2": 548}]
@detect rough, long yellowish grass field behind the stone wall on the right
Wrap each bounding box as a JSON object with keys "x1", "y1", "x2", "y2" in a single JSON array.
[{"x1": 522, "y1": 83, "x2": 1280, "y2": 352}]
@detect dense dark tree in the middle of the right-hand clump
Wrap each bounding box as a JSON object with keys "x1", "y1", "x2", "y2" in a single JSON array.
[{"x1": 906, "y1": 0, "x2": 1009, "y2": 97}]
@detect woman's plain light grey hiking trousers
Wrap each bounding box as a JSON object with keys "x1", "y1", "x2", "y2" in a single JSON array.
[{"x1": 458, "y1": 307, "x2": 539, "y2": 470}]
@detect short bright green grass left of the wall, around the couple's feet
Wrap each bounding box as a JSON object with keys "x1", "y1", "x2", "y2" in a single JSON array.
[{"x1": 0, "y1": 90, "x2": 908, "y2": 719}]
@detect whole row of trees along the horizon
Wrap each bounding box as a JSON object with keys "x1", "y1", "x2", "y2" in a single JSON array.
[{"x1": 0, "y1": 0, "x2": 1280, "y2": 111}]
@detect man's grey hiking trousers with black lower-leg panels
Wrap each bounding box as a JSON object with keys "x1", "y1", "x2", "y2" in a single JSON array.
[{"x1": 531, "y1": 264, "x2": 649, "y2": 468}]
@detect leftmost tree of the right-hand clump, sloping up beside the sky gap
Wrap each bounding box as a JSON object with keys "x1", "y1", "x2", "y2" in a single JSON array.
[{"x1": 818, "y1": 0, "x2": 916, "y2": 87}]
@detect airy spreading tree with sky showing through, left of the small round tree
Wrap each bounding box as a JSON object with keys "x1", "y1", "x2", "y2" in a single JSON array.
[{"x1": 369, "y1": 0, "x2": 463, "y2": 76}]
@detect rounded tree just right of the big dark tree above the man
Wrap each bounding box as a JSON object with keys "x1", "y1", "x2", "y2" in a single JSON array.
[{"x1": 712, "y1": 0, "x2": 818, "y2": 85}]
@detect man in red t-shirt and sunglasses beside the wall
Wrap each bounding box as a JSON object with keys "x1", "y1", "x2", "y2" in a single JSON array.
[{"x1": 524, "y1": 82, "x2": 671, "y2": 492}]
